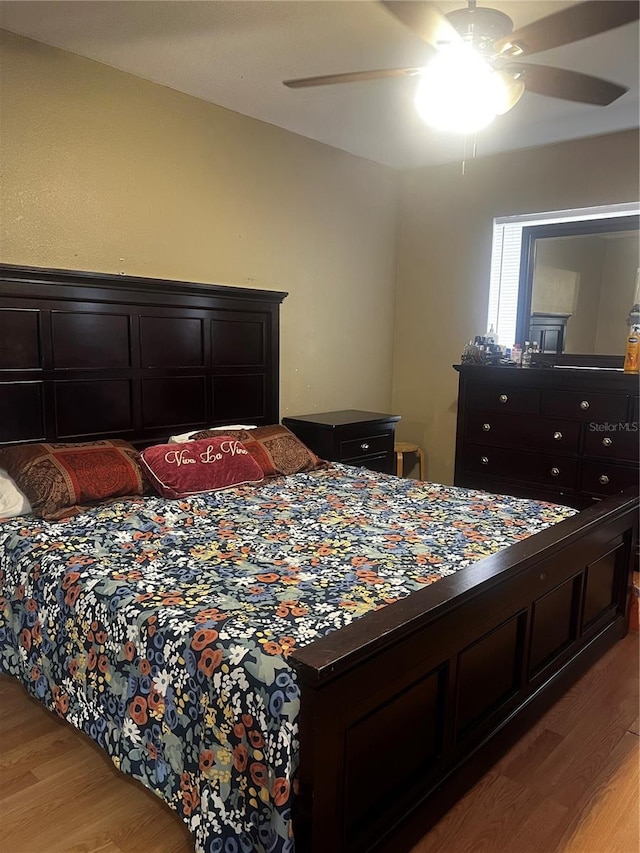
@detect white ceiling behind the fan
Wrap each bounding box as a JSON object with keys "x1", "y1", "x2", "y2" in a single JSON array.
[{"x1": 0, "y1": 0, "x2": 639, "y2": 169}]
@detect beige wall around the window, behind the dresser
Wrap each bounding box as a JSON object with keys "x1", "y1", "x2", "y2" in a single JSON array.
[{"x1": 392, "y1": 131, "x2": 638, "y2": 482}]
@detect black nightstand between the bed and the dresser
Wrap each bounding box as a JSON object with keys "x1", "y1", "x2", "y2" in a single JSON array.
[{"x1": 282, "y1": 409, "x2": 400, "y2": 474}]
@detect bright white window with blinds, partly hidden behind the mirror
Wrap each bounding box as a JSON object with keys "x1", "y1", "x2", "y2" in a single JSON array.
[{"x1": 487, "y1": 202, "x2": 640, "y2": 347}]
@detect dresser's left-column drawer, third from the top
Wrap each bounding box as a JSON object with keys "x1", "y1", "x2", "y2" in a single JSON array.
[{"x1": 463, "y1": 444, "x2": 578, "y2": 489}]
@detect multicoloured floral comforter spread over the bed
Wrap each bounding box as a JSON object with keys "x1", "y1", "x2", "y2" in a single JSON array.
[{"x1": 0, "y1": 465, "x2": 573, "y2": 853}]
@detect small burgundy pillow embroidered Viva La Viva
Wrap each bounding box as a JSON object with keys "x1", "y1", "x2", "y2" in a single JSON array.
[{"x1": 140, "y1": 435, "x2": 263, "y2": 498}]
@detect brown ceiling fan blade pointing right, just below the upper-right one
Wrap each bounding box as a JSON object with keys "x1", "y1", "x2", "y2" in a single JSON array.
[{"x1": 503, "y1": 63, "x2": 628, "y2": 107}]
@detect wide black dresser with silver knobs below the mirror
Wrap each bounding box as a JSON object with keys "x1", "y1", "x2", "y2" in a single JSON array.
[{"x1": 455, "y1": 365, "x2": 640, "y2": 509}]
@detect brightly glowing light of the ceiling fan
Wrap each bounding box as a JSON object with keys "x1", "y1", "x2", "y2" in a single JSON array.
[{"x1": 415, "y1": 45, "x2": 524, "y2": 133}]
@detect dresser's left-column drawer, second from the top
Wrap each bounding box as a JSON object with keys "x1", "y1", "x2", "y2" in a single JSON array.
[{"x1": 466, "y1": 409, "x2": 581, "y2": 455}]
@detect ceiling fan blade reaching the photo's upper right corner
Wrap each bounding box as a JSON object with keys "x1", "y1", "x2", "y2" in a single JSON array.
[{"x1": 493, "y1": 0, "x2": 640, "y2": 56}]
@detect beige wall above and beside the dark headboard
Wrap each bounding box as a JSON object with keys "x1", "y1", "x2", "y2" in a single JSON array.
[{"x1": 0, "y1": 31, "x2": 398, "y2": 415}]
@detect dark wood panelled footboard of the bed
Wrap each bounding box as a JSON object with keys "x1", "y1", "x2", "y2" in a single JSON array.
[{"x1": 291, "y1": 489, "x2": 639, "y2": 853}]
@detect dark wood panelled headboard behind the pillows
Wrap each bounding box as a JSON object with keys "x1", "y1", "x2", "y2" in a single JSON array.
[{"x1": 0, "y1": 264, "x2": 287, "y2": 445}]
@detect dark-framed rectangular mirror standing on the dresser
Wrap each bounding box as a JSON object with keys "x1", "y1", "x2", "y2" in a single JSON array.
[{"x1": 516, "y1": 214, "x2": 640, "y2": 361}]
